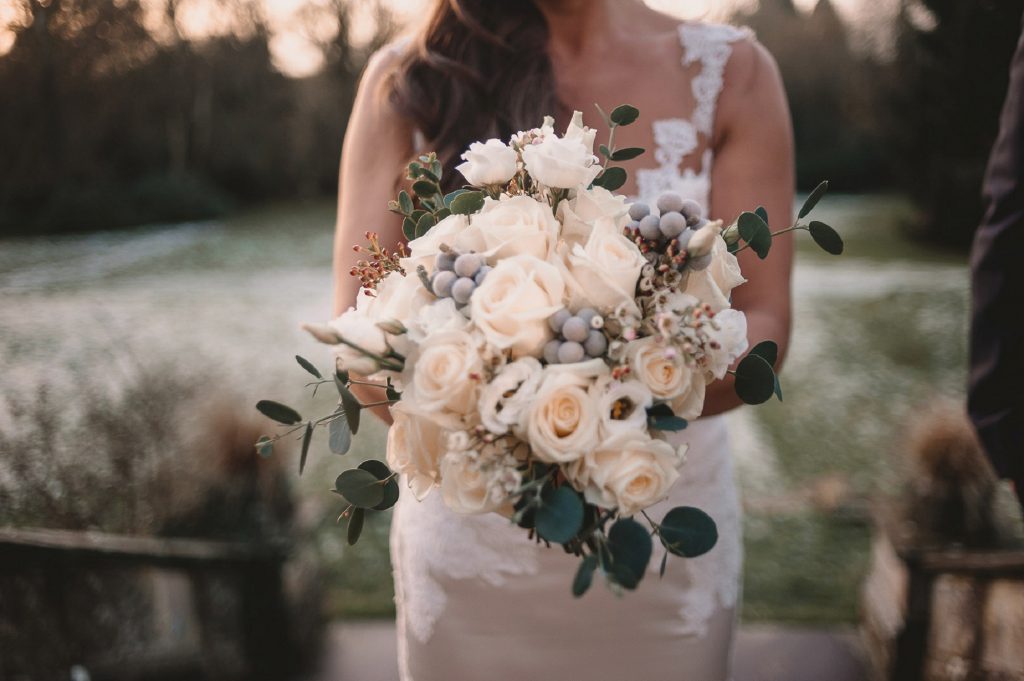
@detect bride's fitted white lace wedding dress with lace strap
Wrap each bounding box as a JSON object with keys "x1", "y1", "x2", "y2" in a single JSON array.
[{"x1": 391, "y1": 24, "x2": 749, "y2": 681}]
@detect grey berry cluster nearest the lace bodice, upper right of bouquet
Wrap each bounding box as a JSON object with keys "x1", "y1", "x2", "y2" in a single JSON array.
[{"x1": 626, "y1": 191, "x2": 711, "y2": 270}]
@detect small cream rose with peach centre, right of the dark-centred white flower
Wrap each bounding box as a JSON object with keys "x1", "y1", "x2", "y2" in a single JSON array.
[{"x1": 626, "y1": 336, "x2": 705, "y2": 419}]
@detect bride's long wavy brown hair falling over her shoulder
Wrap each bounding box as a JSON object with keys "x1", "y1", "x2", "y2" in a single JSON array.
[{"x1": 388, "y1": 0, "x2": 558, "y2": 189}]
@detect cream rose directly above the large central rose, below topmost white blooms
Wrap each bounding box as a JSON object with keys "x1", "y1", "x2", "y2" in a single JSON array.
[{"x1": 466, "y1": 196, "x2": 560, "y2": 262}]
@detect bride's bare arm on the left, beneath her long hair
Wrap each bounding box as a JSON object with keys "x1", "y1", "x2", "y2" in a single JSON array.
[{"x1": 334, "y1": 48, "x2": 413, "y2": 423}]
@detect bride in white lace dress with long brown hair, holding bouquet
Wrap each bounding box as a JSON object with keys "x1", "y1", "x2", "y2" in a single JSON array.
[{"x1": 335, "y1": 0, "x2": 794, "y2": 681}]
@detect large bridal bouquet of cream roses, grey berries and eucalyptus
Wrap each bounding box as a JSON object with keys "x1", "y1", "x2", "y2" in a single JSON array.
[{"x1": 257, "y1": 105, "x2": 843, "y2": 595}]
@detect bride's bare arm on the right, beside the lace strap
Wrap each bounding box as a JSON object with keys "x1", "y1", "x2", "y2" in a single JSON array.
[{"x1": 705, "y1": 40, "x2": 794, "y2": 416}]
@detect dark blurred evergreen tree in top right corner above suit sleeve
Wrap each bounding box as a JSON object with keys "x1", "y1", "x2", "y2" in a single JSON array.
[{"x1": 880, "y1": 0, "x2": 1024, "y2": 248}]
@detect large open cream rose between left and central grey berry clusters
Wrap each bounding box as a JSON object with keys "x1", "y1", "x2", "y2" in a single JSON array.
[{"x1": 469, "y1": 255, "x2": 565, "y2": 357}]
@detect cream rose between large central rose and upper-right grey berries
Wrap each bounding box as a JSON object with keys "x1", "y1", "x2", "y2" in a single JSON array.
[{"x1": 565, "y1": 217, "x2": 647, "y2": 312}]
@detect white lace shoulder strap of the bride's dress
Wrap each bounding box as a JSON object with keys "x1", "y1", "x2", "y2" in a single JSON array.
[{"x1": 679, "y1": 23, "x2": 754, "y2": 136}]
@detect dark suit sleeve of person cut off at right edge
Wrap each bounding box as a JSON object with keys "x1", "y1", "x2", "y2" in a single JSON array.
[{"x1": 968, "y1": 27, "x2": 1024, "y2": 483}]
